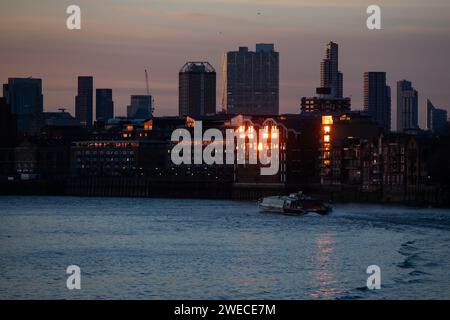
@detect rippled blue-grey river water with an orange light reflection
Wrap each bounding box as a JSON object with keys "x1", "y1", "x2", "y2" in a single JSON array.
[{"x1": 0, "y1": 197, "x2": 450, "y2": 299}]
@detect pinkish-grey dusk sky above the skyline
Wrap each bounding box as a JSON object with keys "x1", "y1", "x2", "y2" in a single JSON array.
[{"x1": 0, "y1": 0, "x2": 450, "y2": 128}]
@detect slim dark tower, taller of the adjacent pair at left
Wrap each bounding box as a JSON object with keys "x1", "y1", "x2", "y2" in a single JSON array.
[{"x1": 75, "y1": 76, "x2": 94, "y2": 127}]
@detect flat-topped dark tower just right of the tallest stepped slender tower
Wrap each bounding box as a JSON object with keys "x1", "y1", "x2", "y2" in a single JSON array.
[{"x1": 364, "y1": 72, "x2": 391, "y2": 131}]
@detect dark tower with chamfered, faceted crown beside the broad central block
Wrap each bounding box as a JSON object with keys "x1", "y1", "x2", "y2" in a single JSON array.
[{"x1": 178, "y1": 62, "x2": 216, "y2": 116}]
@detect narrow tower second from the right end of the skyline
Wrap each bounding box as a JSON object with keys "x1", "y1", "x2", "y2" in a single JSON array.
[{"x1": 397, "y1": 80, "x2": 419, "y2": 132}]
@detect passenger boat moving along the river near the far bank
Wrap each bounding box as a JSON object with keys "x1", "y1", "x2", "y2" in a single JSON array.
[{"x1": 258, "y1": 191, "x2": 332, "y2": 216}]
